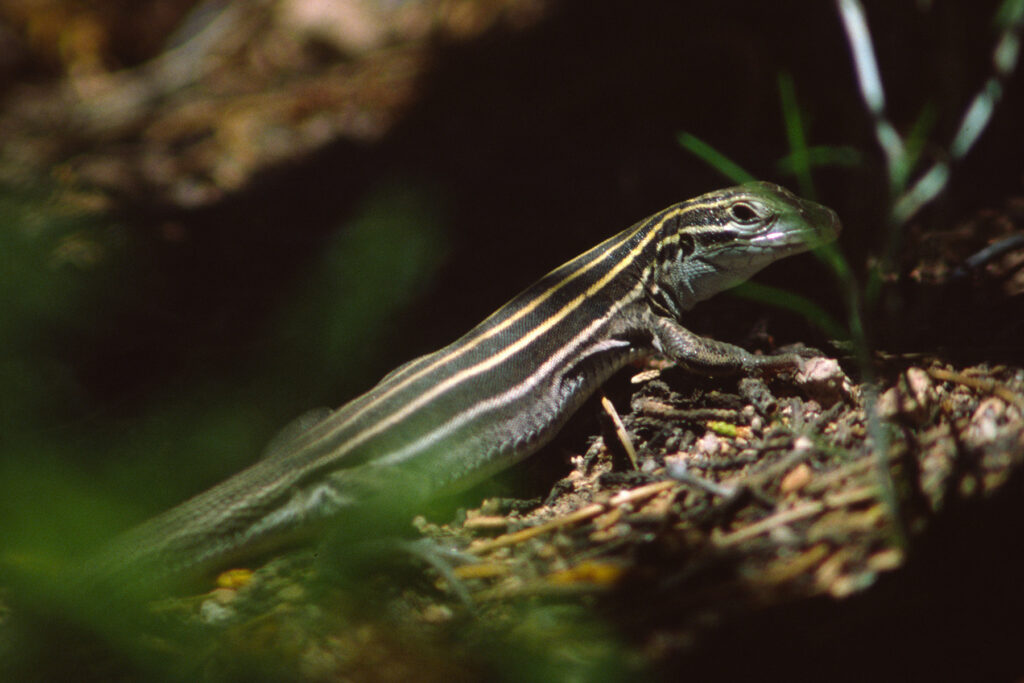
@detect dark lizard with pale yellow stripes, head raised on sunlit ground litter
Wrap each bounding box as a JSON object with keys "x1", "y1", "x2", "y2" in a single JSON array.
[{"x1": 90, "y1": 182, "x2": 840, "y2": 589}]
